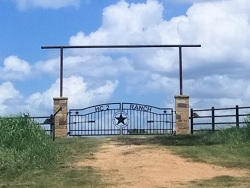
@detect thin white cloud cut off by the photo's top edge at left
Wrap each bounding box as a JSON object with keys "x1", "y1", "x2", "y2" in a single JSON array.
[{"x1": 11, "y1": 0, "x2": 80, "y2": 10}]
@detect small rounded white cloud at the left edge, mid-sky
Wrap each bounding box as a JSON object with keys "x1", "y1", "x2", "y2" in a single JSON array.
[{"x1": 0, "y1": 56, "x2": 31, "y2": 80}]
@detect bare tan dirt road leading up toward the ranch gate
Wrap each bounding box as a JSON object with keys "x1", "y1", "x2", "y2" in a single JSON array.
[{"x1": 76, "y1": 142, "x2": 248, "y2": 188}]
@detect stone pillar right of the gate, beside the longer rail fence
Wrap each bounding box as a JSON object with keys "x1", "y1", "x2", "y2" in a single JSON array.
[{"x1": 175, "y1": 95, "x2": 190, "y2": 134}]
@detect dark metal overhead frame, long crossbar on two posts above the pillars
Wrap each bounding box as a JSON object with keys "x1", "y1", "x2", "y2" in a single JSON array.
[{"x1": 41, "y1": 44, "x2": 201, "y2": 97}]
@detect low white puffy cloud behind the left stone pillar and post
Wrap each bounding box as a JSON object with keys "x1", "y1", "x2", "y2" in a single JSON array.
[{"x1": 26, "y1": 76, "x2": 118, "y2": 113}]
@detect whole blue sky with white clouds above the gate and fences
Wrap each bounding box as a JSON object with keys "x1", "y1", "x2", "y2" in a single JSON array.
[{"x1": 0, "y1": 0, "x2": 250, "y2": 115}]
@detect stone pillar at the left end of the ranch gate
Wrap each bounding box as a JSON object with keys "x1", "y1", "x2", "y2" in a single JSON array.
[{"x1": 54, "y1": 97, "x2": 68, "y2": 138}]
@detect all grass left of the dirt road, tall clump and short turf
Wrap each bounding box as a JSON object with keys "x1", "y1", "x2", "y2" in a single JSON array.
[{"x1": 0, "y1": 114, "x2": 106, "y2": 188}]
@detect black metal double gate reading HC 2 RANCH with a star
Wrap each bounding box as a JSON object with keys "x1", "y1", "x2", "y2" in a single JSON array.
[{"x1": 68, "y1": 103, "x2": 173, "y2": 136}]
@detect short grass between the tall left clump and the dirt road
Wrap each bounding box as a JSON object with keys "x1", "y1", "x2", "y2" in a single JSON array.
[{"x1": 0, "y1": 138, "x2": 106, "y2": 188}]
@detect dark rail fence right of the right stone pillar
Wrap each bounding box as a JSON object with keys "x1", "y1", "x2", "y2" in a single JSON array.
[{"x1": 189, "y1": 105, "x2": 250, "y2": 134}]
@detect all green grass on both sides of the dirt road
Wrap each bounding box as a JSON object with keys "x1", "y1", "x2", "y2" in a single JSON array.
[{"x1": 0, "y1": 116, "x2": 250, "y2": 188}]
